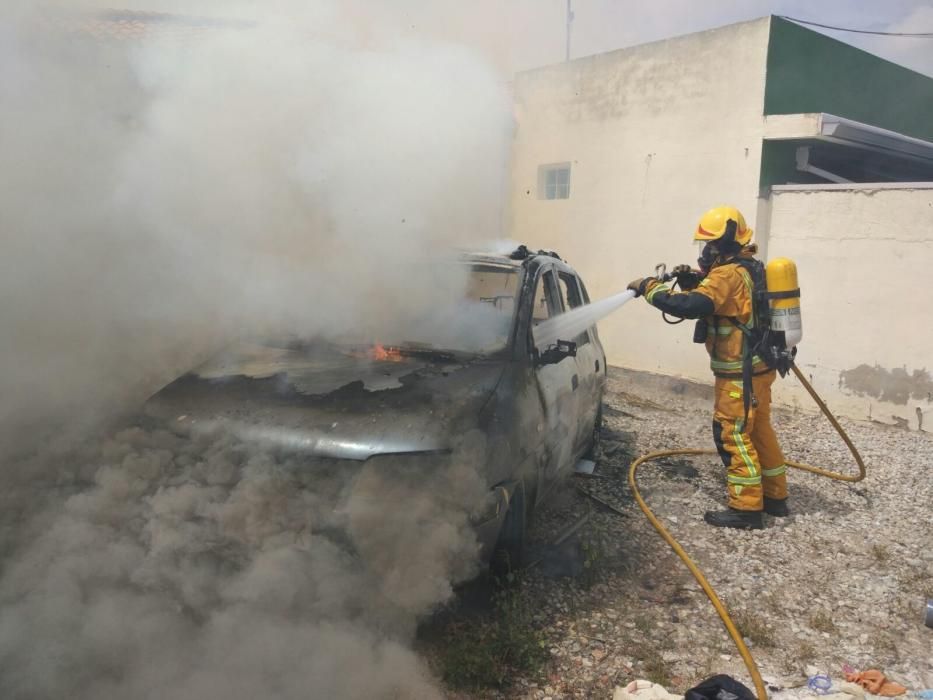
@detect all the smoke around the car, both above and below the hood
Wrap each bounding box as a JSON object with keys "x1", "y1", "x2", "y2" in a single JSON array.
[{"x1": 0, "y1": 2, "x2": 511, "y2": 698}]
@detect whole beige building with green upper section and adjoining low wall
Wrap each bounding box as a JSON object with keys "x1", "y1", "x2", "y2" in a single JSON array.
[{"x1": 509, "y1": 18, "x2": 933, "y2": 428}]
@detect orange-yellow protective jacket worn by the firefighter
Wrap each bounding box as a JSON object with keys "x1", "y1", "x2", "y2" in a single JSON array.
[{"x1": 645, "y1": 247, "x2": 770, "y2": 378}]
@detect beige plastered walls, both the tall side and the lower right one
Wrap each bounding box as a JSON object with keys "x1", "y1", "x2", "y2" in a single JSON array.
[{"x1": 509, "y1": 19, "x2": 933, "y2": 430}]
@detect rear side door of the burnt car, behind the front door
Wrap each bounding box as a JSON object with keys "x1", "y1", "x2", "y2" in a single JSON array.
[{"x1": 557, "y1": 270, "x2": 606, "y2": 451}]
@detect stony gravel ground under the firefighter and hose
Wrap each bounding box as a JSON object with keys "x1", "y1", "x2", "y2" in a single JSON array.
[{"x1": 456, "y1": 370, "x2": 933, "y2": 698}]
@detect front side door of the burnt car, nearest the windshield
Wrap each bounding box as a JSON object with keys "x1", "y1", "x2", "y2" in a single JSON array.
[{"x1": 529, "y1": 266, "x2": 580, "y2": 490}]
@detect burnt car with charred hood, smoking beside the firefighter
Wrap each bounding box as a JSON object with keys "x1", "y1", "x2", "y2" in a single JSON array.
[{"x1": 138, "y1": 247, "x2": 606, "y2": 566}]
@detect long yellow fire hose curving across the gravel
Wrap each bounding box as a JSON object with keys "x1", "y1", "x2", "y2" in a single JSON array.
[{"x1": 628, "y1": 365, "x2": 865, "y2": 700}]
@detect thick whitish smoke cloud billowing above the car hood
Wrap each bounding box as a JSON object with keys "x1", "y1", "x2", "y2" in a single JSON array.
[{"x1": 0, "y1": 3, "x2": 511, "y2": 454}]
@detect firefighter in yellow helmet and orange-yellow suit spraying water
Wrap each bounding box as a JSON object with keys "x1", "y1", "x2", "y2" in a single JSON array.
[{"x1": 628, "y1": 207, "x2": 788, "y2": 530}]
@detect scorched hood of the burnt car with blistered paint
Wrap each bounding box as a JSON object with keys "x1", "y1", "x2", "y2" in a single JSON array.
[{"x1": 143, "y1": 346, "x2": 505, "y2": 460}]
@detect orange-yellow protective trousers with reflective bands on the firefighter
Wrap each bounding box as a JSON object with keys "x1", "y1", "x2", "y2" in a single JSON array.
[{"x1": 713, "y1": 371, "x2": 787, "y2": 510}]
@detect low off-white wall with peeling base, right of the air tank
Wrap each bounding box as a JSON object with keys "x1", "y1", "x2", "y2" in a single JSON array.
[{"x1": 768, "y1": 183, "x2": 933, "y2": 430}]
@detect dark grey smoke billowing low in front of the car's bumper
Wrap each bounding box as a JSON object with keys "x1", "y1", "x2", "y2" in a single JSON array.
[{"x1": 0, "y1": 429, "x2": 484, "y2": 699}]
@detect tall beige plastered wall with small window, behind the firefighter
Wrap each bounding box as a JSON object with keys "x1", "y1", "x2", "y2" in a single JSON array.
[{"x1": 509, "y1": 19, "x2": 769, "y2": 379}]
